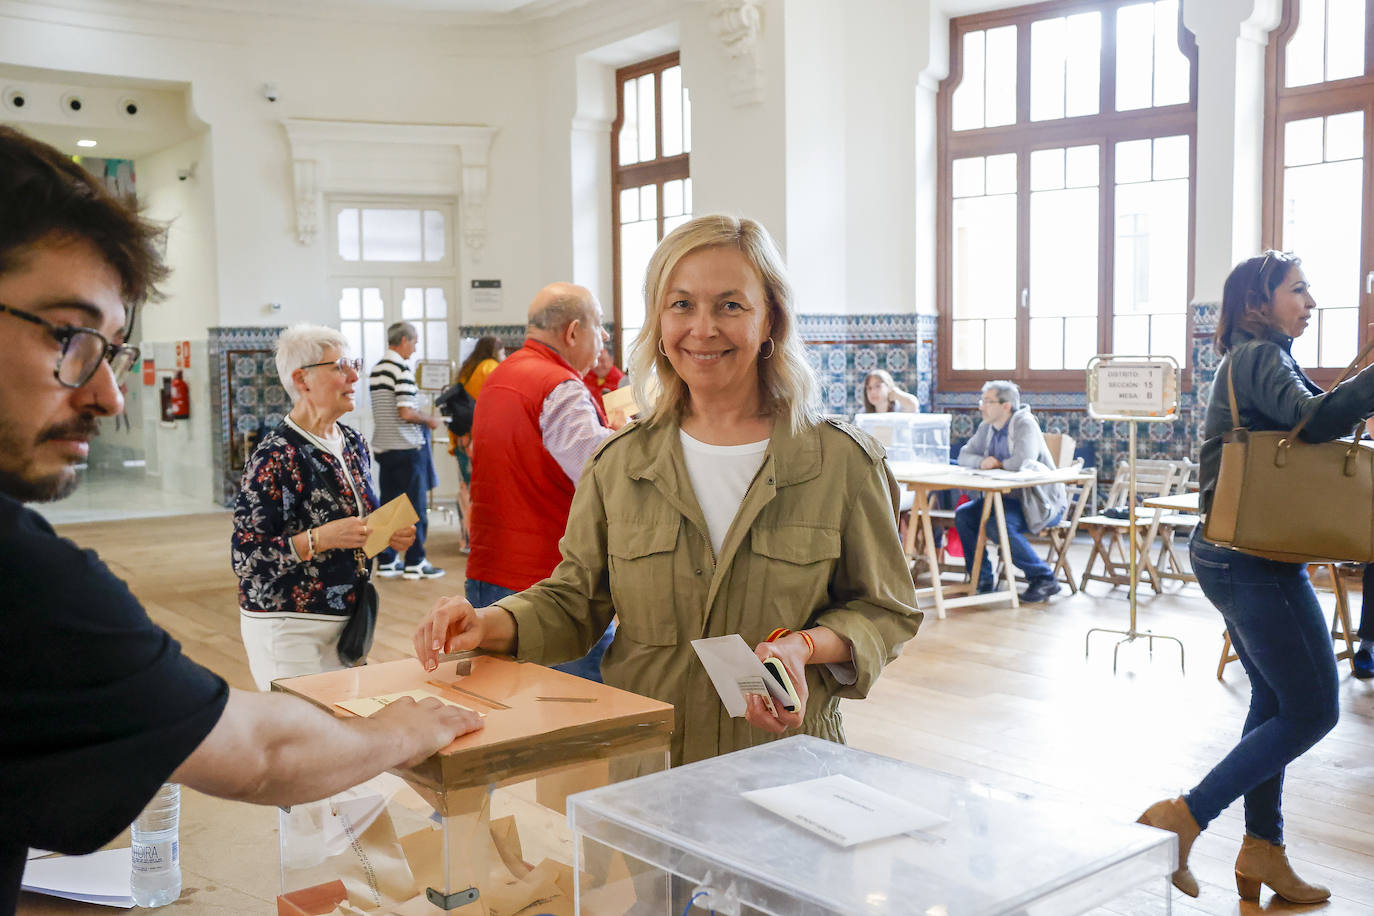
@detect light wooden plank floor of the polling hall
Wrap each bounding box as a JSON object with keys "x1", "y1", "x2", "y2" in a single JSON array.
[{"x1": 21, "y1": 515, "x2": 1374, "y2": 916}]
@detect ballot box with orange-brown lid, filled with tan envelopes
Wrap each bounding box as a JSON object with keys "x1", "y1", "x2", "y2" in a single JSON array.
[{"x1": 272, "y1": 655, "x2": 673, "y2": 916}]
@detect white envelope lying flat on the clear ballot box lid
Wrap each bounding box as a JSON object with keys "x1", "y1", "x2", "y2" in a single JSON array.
[{"x1": 742, "y1": 773, "x2": 947, "y2": 846}]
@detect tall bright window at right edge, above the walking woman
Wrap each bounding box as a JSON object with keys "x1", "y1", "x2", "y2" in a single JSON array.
[{"x1": 1264, "y1": 0, "x2": 1374, "y2": 383}]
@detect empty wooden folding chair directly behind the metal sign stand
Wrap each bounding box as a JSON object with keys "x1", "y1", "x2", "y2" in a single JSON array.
[{"x1": 1079, "y1": 459, "x2": 1179, "y2": 593}]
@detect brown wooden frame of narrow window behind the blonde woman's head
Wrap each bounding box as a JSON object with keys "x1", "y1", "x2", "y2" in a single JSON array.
[{"x1": 610, "y1": 51, "x2": 691, "y2": 365}]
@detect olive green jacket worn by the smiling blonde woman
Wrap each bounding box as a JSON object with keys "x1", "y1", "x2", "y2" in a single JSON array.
[{"x1": 497, "y1": 420, "x2": 922, "y2": 766}]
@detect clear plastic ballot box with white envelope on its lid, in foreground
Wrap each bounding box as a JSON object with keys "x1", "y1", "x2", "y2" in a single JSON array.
[{"x1": 567, "y1": 736, "x2": 1176, "y2": 916}]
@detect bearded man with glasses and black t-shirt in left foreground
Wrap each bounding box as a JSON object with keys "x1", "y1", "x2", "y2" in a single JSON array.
[{"x1": 0, "y1": 126, "x2": 481, "y2": 916}]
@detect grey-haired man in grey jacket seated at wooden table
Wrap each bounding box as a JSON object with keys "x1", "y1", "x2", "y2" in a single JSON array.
[{"x1": 954, "y1": 380, "x2": 1069, "y2": 603}]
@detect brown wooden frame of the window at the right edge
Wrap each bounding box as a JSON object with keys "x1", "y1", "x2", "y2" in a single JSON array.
[{"x1": 1260, "y1": 0, "x2": 1374, "y2": 387}]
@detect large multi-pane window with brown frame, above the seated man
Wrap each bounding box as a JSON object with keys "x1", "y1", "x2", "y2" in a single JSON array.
[{"x1": 938, "y1": 0, "x2": 1197, "y2": 390}]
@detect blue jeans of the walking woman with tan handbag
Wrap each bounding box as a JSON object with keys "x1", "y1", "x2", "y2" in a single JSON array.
[{"x1": 1184, "y1": 526, "x2": 1341, "y2": 843}]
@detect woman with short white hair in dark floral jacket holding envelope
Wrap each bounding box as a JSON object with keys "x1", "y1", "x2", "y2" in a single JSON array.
[{"x1": 232, "y1": 324, "x2": 415, "y2": 691}]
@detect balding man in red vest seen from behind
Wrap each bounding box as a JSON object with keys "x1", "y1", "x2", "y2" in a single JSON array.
[{"x1": 466, "y1": 283, "x2": 616, "y2": 681}]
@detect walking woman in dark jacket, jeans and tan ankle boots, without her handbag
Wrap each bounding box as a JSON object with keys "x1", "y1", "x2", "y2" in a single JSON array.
[{"x1": 1140, "y1": 251, "x2": 1374, "y2": 904}]
